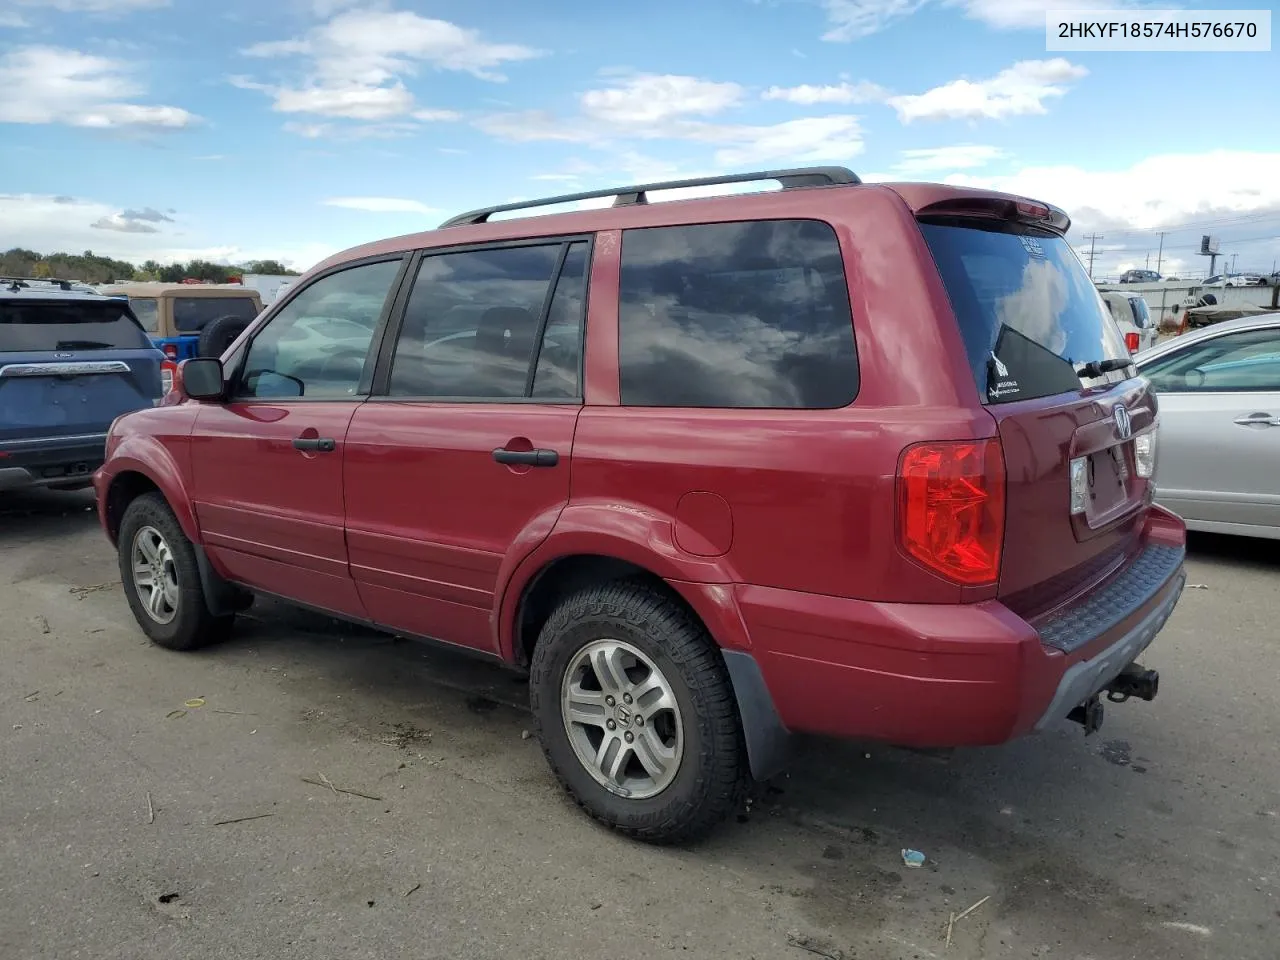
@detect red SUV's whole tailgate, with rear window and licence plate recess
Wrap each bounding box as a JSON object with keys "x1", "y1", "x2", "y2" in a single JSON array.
[{"x1": 922, "y1": 218, "x2": 1156, "y2": 617}]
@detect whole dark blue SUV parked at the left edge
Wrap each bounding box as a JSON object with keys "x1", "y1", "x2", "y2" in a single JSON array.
[{"x1": 0, "y1": 278, "x2": 164, "y2": 490}]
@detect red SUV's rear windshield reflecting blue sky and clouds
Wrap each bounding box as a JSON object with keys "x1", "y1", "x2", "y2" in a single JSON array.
[{"x1": 920, "y1": 221, "x2": 1129, "y2": 403}]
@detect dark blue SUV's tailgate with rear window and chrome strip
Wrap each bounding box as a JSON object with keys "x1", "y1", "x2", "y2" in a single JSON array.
[{"x1": 0, "y1": 293, "x2": 164, "y2": 450}]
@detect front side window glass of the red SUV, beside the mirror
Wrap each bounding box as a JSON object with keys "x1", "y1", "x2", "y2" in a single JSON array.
[{"x1": 237, "y1": 260, "x2": 401, "y2": 399}]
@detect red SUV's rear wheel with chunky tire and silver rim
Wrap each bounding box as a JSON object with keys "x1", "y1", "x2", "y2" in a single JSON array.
[{"x1": 530, "y1": 581, "x2": 746, "y2": 844}]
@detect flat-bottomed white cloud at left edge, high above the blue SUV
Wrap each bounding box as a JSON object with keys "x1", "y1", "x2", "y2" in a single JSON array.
[{"x1": 0, "y1": 46, "x2": 197, "y2": 129}]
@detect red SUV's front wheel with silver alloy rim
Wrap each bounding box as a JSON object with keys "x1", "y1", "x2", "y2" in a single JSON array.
[{"x1": 116, "y1": 493, "x2": 236, "y2": 650}]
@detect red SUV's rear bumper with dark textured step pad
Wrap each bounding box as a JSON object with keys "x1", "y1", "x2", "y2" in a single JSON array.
[{"x1": 737, "y1": 508, "x2": 1185, "y2": 748}]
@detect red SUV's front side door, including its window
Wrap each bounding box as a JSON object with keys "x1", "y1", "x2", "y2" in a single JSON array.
[{"x1": 191, "y1": 257, "x2": 404, "y2": 617}]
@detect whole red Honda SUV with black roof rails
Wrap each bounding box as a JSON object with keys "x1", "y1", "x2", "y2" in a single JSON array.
[{"x1": 96, "y1": 168, "x2": 1185, "y2": 842}]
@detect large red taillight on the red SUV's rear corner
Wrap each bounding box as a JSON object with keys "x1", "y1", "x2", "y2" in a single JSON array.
[{"x1": 897, "y1": 440, "x2": 1005, "y2": 585}]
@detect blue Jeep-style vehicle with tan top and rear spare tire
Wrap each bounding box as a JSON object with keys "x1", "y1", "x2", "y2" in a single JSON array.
[{"x1": 99, "y1": 283, "x2": 262, "y2": 383}]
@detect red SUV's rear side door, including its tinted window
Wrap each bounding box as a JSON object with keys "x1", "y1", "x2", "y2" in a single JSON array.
[{"x1": 344, "y1": 239, "x2": 590, "y2": 653}]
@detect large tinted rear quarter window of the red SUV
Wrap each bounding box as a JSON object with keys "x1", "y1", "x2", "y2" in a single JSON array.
[{"x1": 618, "y1": 220, "x2": 858, "y2": 410}]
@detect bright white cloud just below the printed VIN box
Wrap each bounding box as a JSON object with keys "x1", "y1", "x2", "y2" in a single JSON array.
[{"x1": 888, "y1": 56, "x2": 1088, "y2": 123}]
